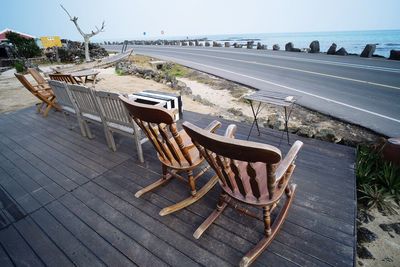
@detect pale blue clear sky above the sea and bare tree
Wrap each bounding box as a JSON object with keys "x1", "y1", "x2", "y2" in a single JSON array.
[{"x1": 0, "y1": 0, "x2": 400, "y2": 40}]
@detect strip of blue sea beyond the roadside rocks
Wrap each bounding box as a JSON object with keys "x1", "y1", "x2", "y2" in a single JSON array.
[{"x1": 97, "y1": 29, "x2": 400, "y2": 58}]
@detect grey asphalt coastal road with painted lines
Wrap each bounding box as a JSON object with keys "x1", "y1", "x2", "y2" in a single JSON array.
[{"x1": 105, "y1": 46, "x2": 400, "y2": 137}]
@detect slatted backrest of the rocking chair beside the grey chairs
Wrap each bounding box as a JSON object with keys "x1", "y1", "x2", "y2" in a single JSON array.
[{"x1": 119, "y1": 96, "x2": 193, "y2": 167}]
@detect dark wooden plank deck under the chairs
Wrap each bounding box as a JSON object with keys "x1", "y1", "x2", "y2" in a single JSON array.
[{"x1": 0, "y1": 108, "x2": 356, "y2": 266}]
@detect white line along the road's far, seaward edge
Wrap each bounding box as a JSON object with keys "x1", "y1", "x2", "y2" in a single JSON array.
[{"x1": 136, "y1": 47, "x2": 400, "y2": 73}]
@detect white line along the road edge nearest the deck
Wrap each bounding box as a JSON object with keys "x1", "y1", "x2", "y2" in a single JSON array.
[{"x1": 141, "y1": 52, "x2": 400, "y2": 123}]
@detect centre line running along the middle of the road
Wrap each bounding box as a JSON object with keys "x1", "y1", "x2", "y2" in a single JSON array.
[{"x1": 139, "y1": 48, "x2": 400, "y2": 90}]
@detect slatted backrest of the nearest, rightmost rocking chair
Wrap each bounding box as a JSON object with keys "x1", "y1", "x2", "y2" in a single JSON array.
[{"x1": 183, "y1": 122, "x2": 282, "y2": 204}]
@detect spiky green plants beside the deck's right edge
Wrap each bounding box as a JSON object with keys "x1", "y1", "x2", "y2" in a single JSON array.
[{"x1": 356, "y1": 145, "x2": 400, "y2": 214}]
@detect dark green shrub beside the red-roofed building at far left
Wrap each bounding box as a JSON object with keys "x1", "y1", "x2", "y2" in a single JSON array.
[{"x1": 6, "y1": 32, "x2": 42, "y2": 58}]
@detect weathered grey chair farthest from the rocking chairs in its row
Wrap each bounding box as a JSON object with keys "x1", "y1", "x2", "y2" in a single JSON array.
[{"x1": 49, "y1": 80, "x2": 86, "y2": 137}]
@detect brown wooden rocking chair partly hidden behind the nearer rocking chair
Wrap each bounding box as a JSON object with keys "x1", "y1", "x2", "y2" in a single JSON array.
[{"x1": 120, "y1": 96, "x2": 221, "y2": 216}]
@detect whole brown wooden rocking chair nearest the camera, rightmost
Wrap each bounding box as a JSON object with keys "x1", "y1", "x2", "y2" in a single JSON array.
[{"x1": 183, "y1": 122, "x2": 303, "y2": 266}]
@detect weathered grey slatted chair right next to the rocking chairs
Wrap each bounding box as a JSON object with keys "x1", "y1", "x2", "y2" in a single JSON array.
[{"x1": 92, "y1": 90, "x2": 148, "y2": 163}]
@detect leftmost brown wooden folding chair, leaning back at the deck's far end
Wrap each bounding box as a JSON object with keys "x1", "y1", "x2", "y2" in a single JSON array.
[{"x1": 14, "y1": 73, "x2": 60, "y2": 117}]
